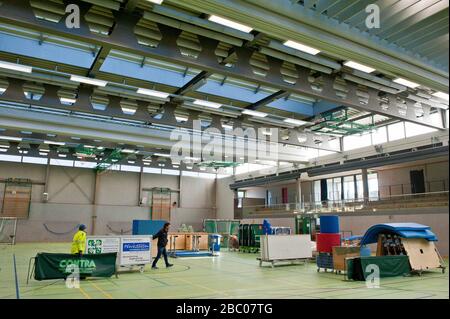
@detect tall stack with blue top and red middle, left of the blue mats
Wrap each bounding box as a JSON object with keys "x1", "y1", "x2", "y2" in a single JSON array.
[{"x1": 316, "y1": 215, "x2": 341, "y2": 271}]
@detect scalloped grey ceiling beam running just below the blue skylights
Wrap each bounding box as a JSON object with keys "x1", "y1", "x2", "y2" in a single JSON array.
[{"x1": 0, "y1": 78, "x2": 341, "y2": 152}]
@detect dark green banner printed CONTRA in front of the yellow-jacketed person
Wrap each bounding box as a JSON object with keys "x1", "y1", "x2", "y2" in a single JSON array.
[{"x1": 34, "y1": 253, "x2": 117, "y2": 280}]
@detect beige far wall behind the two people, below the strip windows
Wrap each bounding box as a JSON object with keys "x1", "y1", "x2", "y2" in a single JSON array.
[{"x1": 0, "y1": 162, "x2": 218, "y2": 242}]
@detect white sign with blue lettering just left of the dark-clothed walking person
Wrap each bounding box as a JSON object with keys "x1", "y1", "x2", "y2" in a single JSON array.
[{"x1": 119, "y1": 236, "x2": 152, "y2": 266}]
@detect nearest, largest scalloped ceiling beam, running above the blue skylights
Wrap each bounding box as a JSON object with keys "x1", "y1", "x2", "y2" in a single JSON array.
[{"x1": 0, "y1": 0, "x2": 444, "y2": 129}]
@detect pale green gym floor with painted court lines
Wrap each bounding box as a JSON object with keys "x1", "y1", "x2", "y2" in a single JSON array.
[{"x1": 0, "y1": 243, "x2": 449, "y2": 299}]
